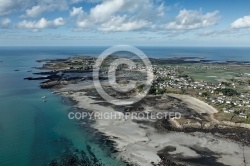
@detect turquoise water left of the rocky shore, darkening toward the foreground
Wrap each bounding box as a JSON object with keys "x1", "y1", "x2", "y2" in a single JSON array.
[{"x1": 0, "y1": 49, "x2": 124, "y2": 166}]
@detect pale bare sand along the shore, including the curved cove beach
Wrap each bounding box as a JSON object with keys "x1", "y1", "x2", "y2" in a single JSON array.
[{"x1": 58, "y1": 84, "x2": 250, "y2": 166}]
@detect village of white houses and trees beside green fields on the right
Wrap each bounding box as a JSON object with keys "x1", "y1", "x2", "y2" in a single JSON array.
[{"x1": 150, "y1": 65, "x2": 250, "y2": 123}]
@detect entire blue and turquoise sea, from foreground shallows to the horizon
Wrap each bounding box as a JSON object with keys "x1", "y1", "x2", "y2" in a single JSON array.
[{"x1": 0, "y1": 47, "x2": 250, "y2": 166}]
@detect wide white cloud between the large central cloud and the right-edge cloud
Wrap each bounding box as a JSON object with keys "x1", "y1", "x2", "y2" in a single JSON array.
[{"x1": 164, "y1": 9, "x2": 219, "y2": 30}]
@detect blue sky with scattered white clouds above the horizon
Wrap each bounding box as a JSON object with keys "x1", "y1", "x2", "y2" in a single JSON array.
[{"x1": 0, "y1": 0, "x2": 250, "y2": 47}]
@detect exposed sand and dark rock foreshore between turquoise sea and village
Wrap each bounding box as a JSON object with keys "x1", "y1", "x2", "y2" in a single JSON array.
[{"x1": 25, "y1": 54, "x2": 250, "y2": 166}]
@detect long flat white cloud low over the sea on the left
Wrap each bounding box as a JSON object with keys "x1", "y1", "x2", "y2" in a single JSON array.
[{"x1": 16, "y1": 17, "x2": 65, "y2": 30}]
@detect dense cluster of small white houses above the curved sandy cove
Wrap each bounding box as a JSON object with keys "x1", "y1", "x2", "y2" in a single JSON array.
[{"x1": 151, "y1": 66, "x2": 250, "y2": 118}]
